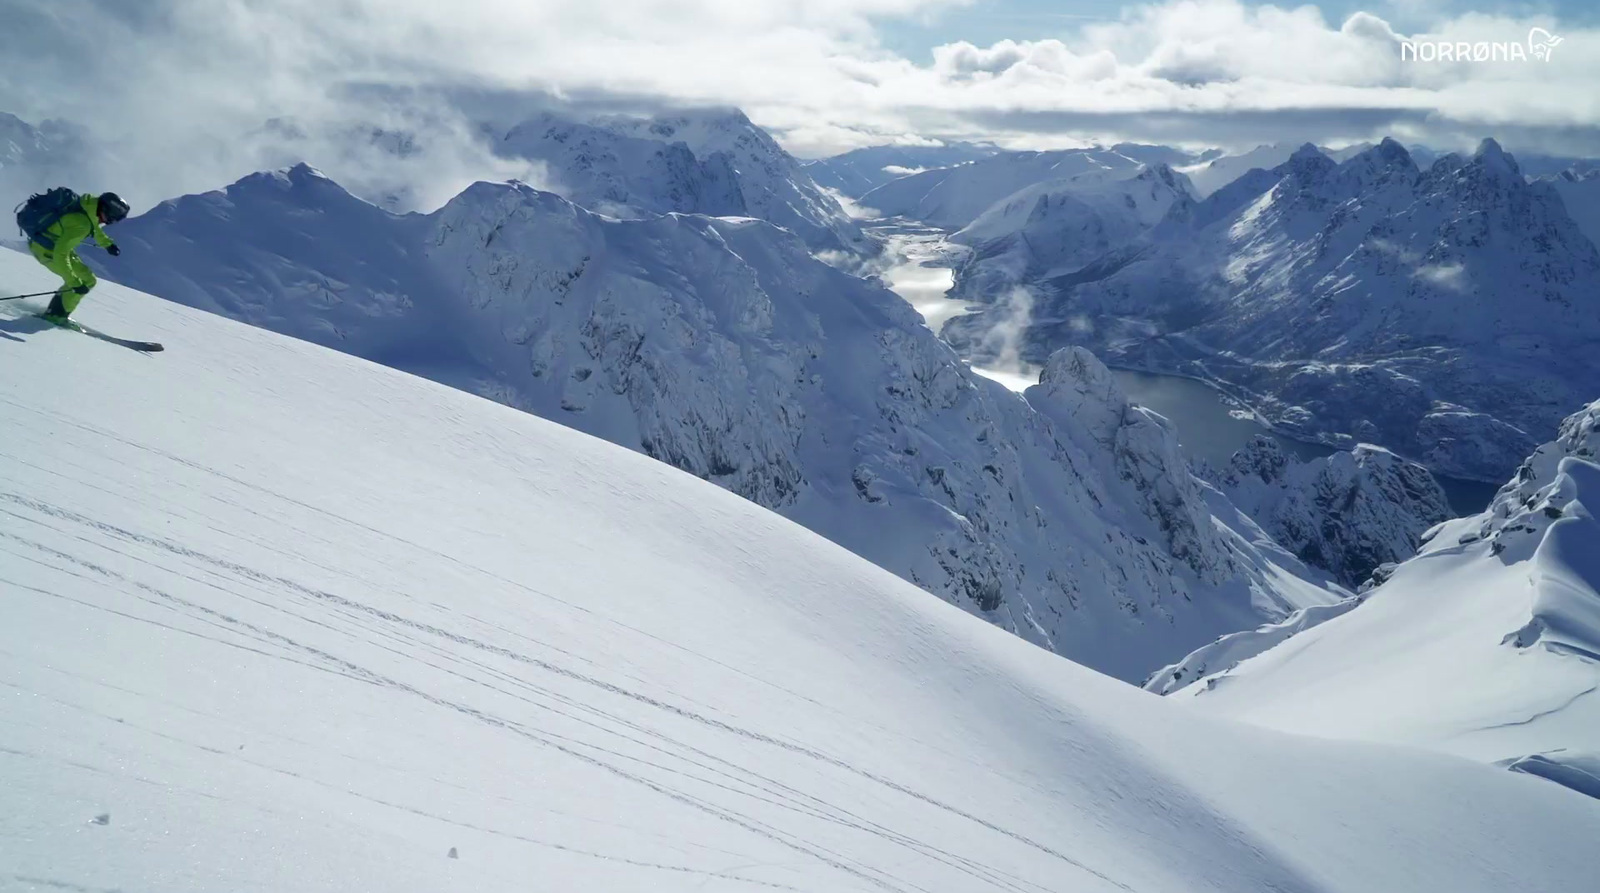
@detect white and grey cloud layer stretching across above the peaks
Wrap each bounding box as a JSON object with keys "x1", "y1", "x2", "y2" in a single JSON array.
[{"x1": 0, "y1": 0, "x2": 1600, "y2": 208}]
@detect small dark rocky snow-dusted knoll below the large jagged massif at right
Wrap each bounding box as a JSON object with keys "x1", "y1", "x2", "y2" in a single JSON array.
[{"x1": 1216, "y1": 437, "x2": 1451, "y2": 589}]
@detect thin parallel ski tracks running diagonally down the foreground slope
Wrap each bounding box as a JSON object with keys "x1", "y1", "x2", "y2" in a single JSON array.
[{"x1": 0, "y1": 400, "x2": 1131, "y2": 891}]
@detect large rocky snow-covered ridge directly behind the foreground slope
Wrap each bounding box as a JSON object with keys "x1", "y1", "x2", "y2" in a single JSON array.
[{"x1": 87, "y1": 166, "x2": 1334, "y2": 680}]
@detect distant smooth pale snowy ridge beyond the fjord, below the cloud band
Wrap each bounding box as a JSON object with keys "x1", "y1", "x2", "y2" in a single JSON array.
[{"x1": 861, "y1": 144, "x2": 1187, "y2": 230}]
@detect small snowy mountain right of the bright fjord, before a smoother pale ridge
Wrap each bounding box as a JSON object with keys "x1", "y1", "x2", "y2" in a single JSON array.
[{"x1": 950, "y1": 165, "x2": 1194, "y2": 299}]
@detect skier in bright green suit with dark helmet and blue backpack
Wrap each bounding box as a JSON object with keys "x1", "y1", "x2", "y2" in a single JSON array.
[{"x1": 16, "y1": 187, "x2": 128, "y2": 325}]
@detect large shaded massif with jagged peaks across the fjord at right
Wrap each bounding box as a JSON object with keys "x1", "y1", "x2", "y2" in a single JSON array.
[{"x1": 946, "y1": 139, "x2": 1600, "y2": 480}]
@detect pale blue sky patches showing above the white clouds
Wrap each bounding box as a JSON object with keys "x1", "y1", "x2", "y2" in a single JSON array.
[{"x1": 880, "y1": 0, "x2": 1600, "y2": 62}]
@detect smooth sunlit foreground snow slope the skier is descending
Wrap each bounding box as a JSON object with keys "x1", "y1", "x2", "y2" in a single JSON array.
[{"x1": 0, "y1": 251, "x2": 1600, "y2": 893}]
